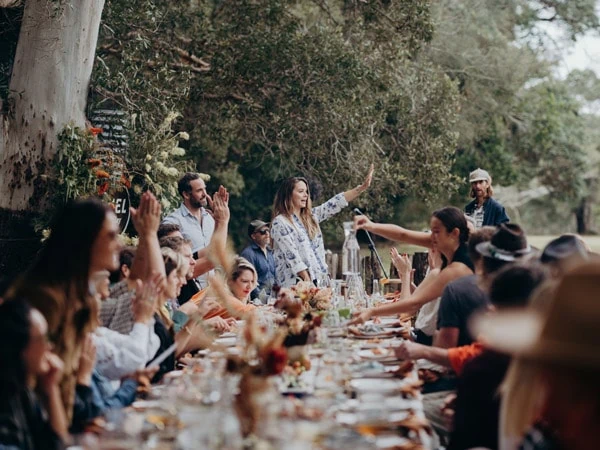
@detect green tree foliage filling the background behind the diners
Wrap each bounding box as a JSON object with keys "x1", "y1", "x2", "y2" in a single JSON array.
[{"x1": 93, "y1": 0, "x2": 598, "y2": 244}]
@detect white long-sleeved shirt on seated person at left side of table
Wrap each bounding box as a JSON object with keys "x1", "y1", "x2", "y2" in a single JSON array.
[{"x1": 93, "y1": 319, "x2": 160, "y2": 380}]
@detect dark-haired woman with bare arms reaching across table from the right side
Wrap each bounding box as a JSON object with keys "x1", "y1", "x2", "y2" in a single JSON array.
[{"x1": 353, "y1": 206, "x2": 473, "y2": 323}]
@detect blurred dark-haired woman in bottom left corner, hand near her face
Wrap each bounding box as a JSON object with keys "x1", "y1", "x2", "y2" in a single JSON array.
[{"x1": 0, "y1": 299, "x2": 67, "y2": 450}]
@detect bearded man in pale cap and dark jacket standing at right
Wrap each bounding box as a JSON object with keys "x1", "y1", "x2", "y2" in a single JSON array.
[{"x1": 465, "y1": 169, "x2": 510, "y2": 228}]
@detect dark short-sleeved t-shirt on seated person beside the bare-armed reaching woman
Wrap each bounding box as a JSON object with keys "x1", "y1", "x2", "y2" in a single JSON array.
[{"x1": 437, "y1": 275, "x2": 489, "y2": 347}]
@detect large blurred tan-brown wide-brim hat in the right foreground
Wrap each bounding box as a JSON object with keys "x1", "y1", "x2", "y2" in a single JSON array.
[{"x1": 471, "y1": 262, "x2": 600, "y2": 370}]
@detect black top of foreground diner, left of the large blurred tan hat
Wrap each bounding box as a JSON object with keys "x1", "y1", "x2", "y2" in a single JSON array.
[{"x1": 447, "y1": 350, "x2": 510, "y2": 450}]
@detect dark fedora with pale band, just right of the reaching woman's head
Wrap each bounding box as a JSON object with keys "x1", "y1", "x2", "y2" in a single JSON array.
[{"x1": 475, "y1": 223, "x2": 531, "y2": 261}]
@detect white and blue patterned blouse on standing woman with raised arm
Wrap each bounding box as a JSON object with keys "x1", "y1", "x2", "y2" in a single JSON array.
[{"x1": 271, "y1": 193, "x2": 348, "y2": 287}]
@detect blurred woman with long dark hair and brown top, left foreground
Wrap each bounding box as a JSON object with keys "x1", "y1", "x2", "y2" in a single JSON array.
[{"x1": 9, "y1": 198, "x2": 121, "y2": 419}]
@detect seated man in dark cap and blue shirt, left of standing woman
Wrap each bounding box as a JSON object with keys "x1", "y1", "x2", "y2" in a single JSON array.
[{"x1": 240, "y1": 219, "x2": 275, "y2": 299}]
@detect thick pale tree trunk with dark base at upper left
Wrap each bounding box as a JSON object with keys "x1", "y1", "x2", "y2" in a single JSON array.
[{"x1": 0, "y1": 0, "x2": 104, "y2": 282}]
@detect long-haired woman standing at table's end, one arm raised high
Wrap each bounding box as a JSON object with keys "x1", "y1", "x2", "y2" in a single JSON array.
[{"x1": 271, "y1": 165, "x2": 373, "y2": 287}]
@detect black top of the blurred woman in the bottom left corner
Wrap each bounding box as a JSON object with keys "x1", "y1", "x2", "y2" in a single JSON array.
[{"x1": 0, "y1": 389, "x2": 64, "y2": 450}]
